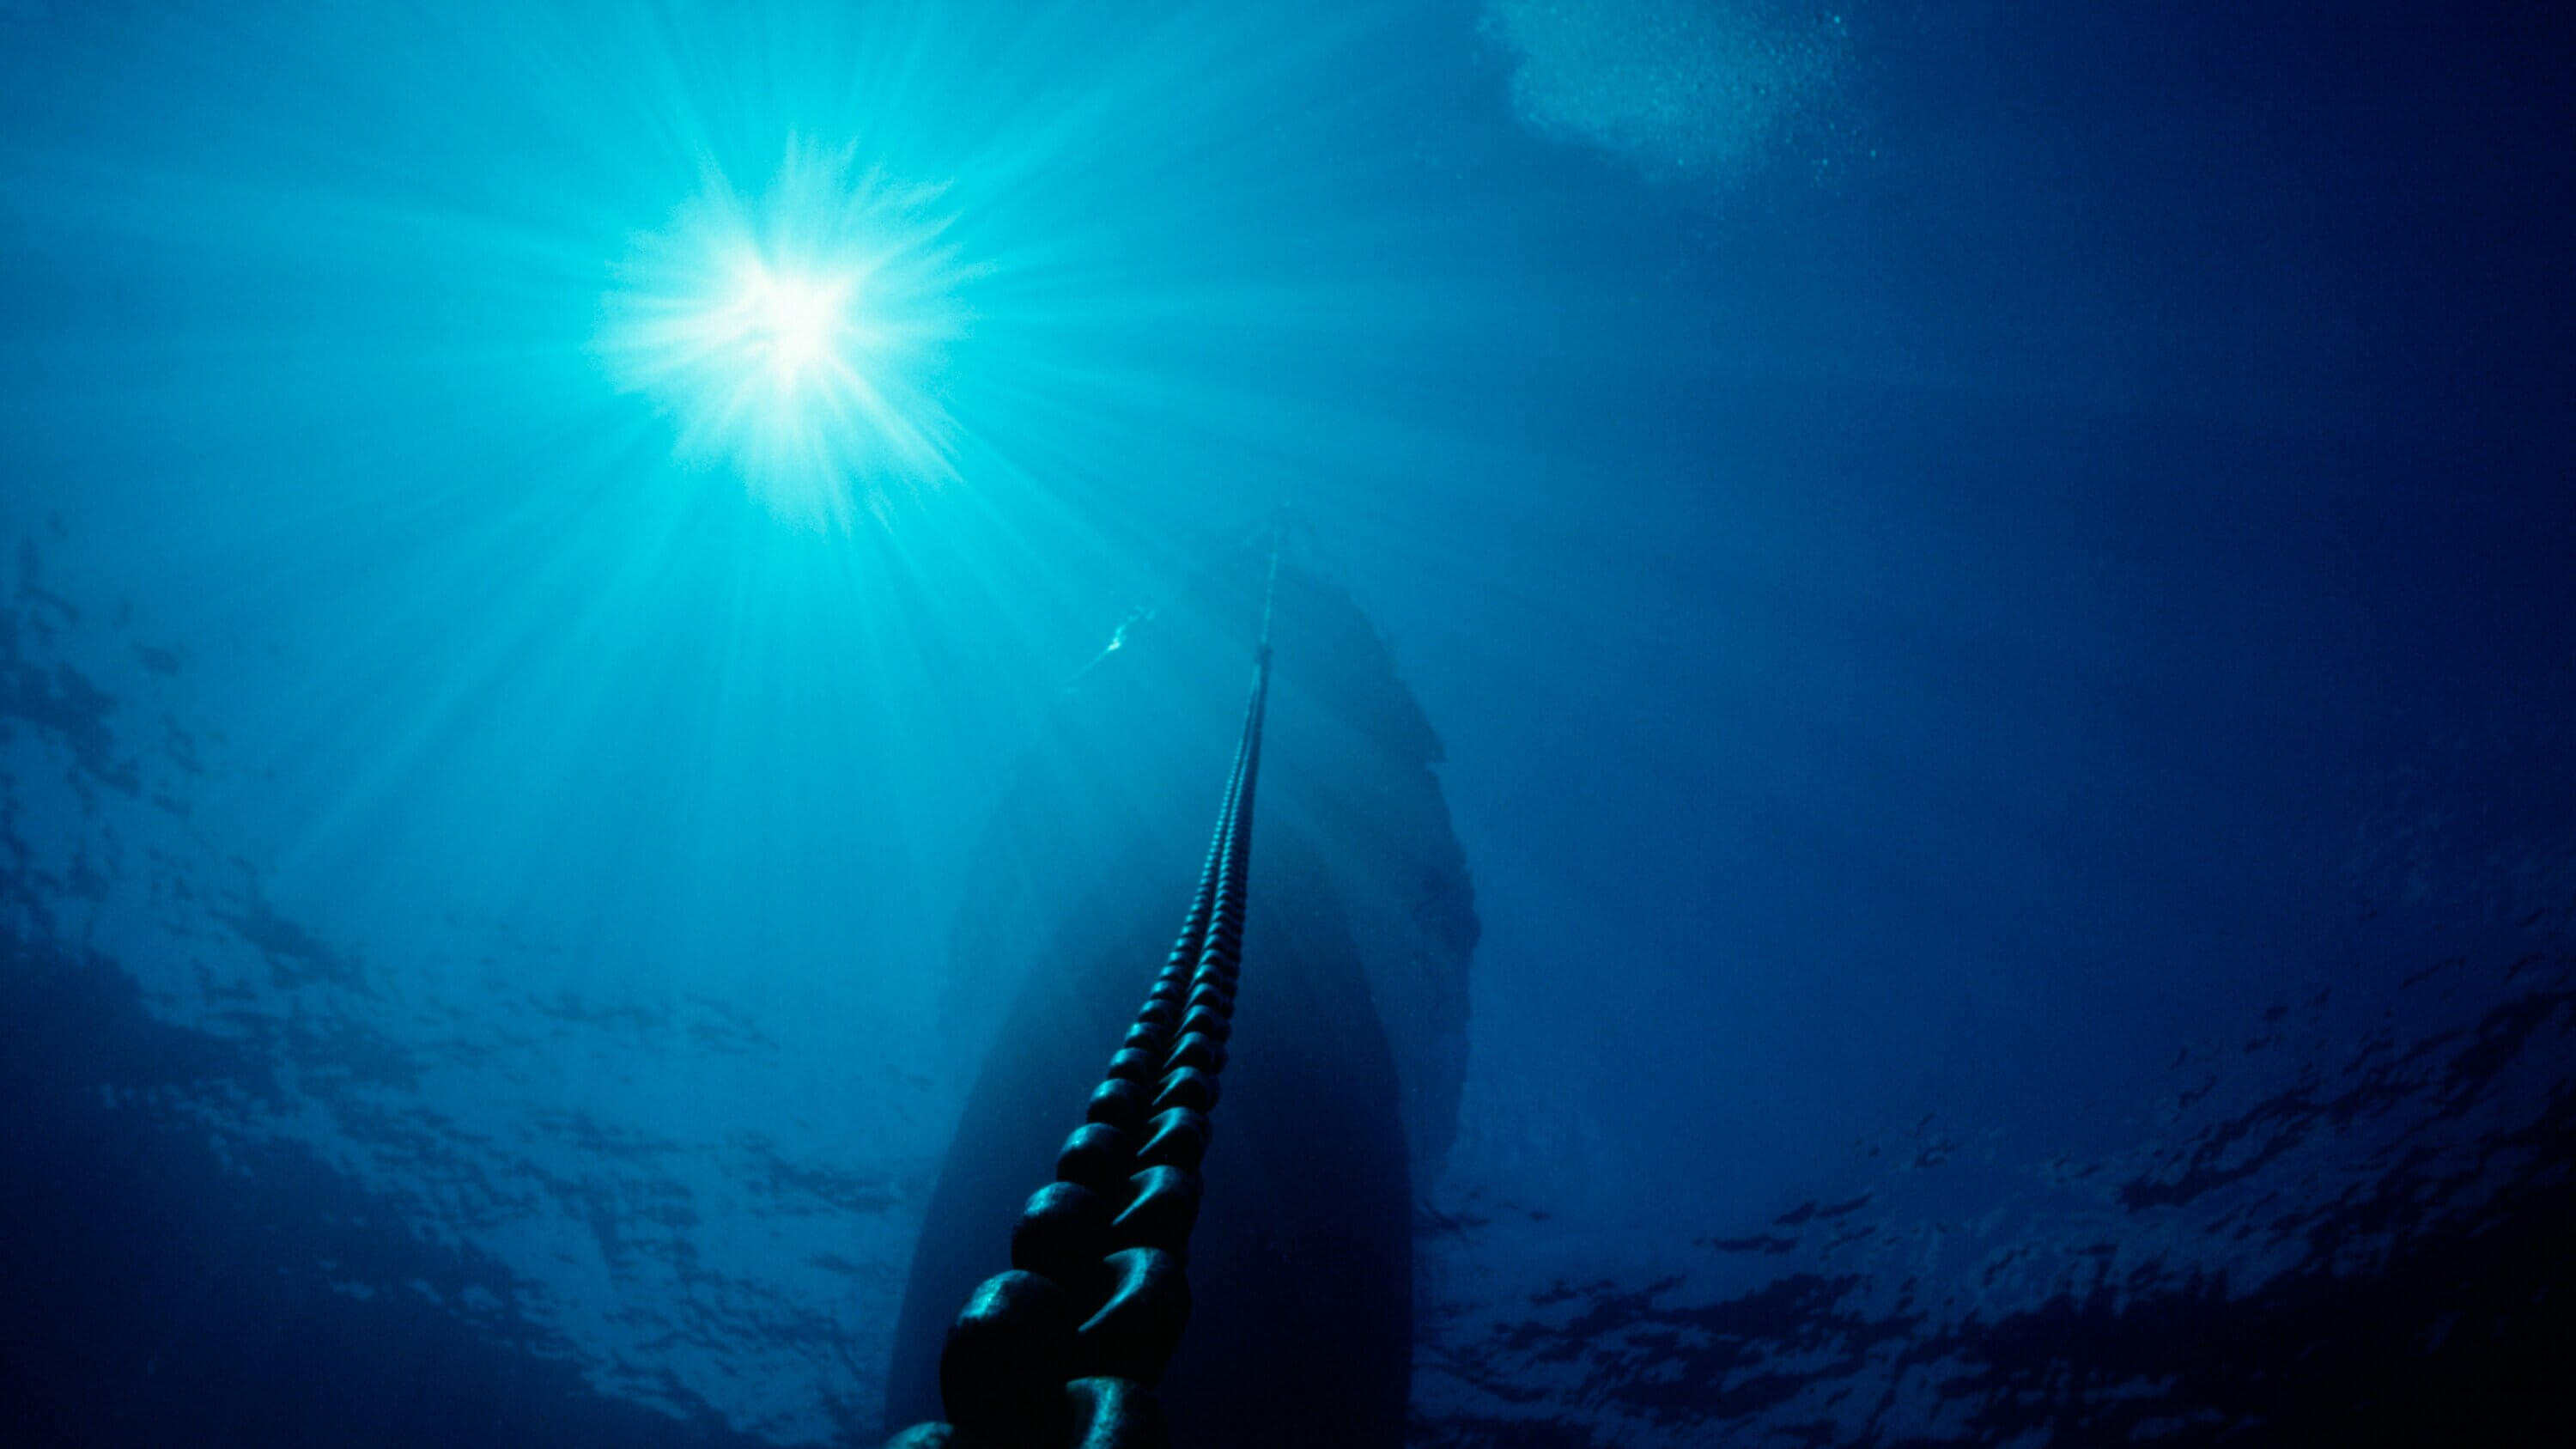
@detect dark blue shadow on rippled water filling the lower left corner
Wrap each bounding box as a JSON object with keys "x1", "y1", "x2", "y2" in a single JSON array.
[{"x1": 0, "y1": 934, "x2": 760, "y2": 1449}]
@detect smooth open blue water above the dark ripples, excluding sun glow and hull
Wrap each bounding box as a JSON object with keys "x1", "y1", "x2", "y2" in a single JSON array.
[{"x1": 0, "y1": 0, "x2": 2576, "y2": 1441}]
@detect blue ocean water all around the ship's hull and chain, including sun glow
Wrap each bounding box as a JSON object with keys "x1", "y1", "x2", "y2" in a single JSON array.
[{"x1": 0, "y1": 0, "x2": 2576, "y2": 1449}]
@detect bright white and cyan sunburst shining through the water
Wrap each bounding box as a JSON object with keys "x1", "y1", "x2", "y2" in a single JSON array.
[{"x1": 600, "y1": 142, "x2": 966, "y2": 526}]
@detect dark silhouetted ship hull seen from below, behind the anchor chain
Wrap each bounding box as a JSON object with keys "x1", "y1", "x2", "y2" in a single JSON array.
[{"x1": 886, "y1": 536, "x2": 1476, "y2": 1449}]
